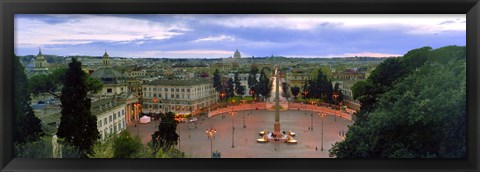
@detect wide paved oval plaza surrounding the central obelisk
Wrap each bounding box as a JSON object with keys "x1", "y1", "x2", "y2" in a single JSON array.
[{"x1": 127, "y1": 110, "x2": 353, "y2": 158}]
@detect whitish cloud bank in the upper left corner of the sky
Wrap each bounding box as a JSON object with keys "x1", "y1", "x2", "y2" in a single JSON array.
[{"x1": 15, "y1": 15, "x2": 191, "y2": 46}]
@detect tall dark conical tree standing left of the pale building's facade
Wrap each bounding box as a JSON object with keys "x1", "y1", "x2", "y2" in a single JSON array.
[{"x1": 57, "y1": 58, "x2": 100, "y2": 157}]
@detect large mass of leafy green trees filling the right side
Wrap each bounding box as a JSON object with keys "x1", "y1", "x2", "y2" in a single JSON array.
[{"x1": 330, "y1": 46, "x2": 466, "y2": 158}]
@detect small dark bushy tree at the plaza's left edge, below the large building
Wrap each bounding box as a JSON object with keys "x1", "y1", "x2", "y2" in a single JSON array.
[{"x1": 152, "y1": 112, "x2": 179, "y2": 152}]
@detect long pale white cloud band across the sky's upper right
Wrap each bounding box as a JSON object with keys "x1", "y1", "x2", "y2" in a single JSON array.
[{"x1": 196, "y1": 14, "x2": 466, "y2": 34}]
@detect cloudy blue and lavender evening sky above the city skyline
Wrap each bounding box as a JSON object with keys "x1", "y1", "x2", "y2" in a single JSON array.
[{"x1": 14, "y1": 14, "x2": 466, "y2": 58}]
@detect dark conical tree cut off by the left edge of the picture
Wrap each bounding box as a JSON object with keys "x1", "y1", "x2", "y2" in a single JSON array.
[{"x1": 13, "y1": 56, "x2": 44, "y2": 144}]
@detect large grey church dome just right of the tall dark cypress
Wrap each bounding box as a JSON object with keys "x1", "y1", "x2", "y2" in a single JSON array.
[{"x1": 91, "y1": 66, "x2": 125, "y2": 84}]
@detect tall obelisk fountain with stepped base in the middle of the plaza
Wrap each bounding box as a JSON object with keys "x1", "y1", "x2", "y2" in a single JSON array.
[{"x1": 257, "y1": 66, "x2": 297, "y2": 144}]
